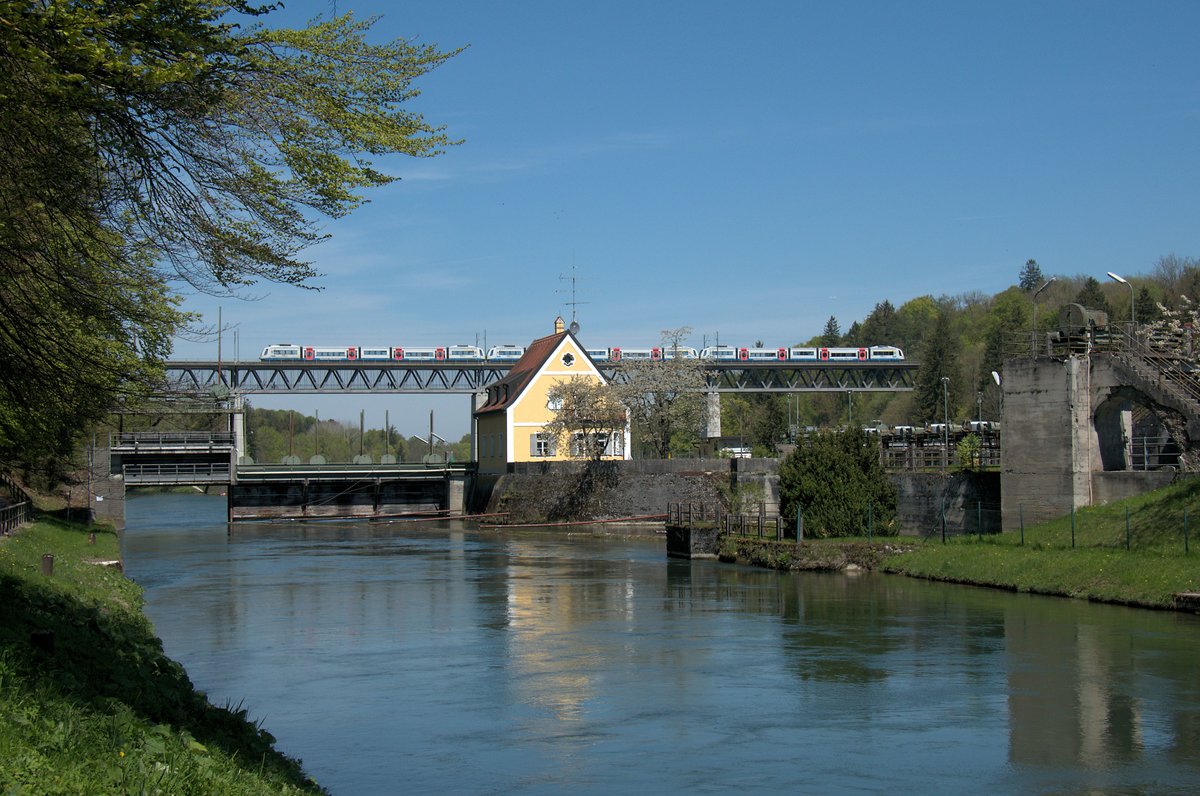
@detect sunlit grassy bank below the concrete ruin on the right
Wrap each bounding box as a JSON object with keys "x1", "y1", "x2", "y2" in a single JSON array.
[{"x1": 721, "y1": 480, "x2": 1200, "y2": 609}]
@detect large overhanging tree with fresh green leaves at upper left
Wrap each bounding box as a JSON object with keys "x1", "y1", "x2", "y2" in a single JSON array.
[{"x1": 0, "y1": 0, "x2": 454, "y2": 466}]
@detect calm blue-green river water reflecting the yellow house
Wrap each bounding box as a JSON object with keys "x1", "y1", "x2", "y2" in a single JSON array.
[{"x1": 124, "y1": 496, "x2": 1200, "y2": 795}]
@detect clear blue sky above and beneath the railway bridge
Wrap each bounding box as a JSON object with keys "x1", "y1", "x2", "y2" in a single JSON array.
[{"x1": 175, "y1": 0, "x2": 1200, "y2": 437}]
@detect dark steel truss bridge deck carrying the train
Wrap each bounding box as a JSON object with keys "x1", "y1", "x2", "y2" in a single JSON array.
[{"x1": 167, "y1": 361, "x2": 918, "y2": 395}]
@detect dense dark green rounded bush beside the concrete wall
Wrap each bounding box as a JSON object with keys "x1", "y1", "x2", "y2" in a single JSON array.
[{"x1": 779, "y1": 429, "x2": 896, "y2": 538}]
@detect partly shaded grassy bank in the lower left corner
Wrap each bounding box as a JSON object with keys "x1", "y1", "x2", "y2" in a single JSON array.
[{"x1": 0, "y1": 520, "x2": 322, "y2": 796}]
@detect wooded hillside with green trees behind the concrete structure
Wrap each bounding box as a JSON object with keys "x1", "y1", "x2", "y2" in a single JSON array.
[{"x1": 715, "y1": 255, "x2": 1200, "y2": 455}]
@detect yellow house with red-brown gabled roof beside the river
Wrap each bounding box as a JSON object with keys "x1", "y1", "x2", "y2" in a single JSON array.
[{"x1": 475, "y1": 318, "x2": 630, "y2": 473}]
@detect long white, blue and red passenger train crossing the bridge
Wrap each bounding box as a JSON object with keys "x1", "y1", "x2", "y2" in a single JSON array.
[{"x1": 260, "y1": 343, "x2": 904, "y2": 364}]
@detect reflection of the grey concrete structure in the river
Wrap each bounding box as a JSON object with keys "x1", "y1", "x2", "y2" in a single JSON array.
[{"x1": 1006, "y1": 610, "x2": 1144, "y2": 768}]
